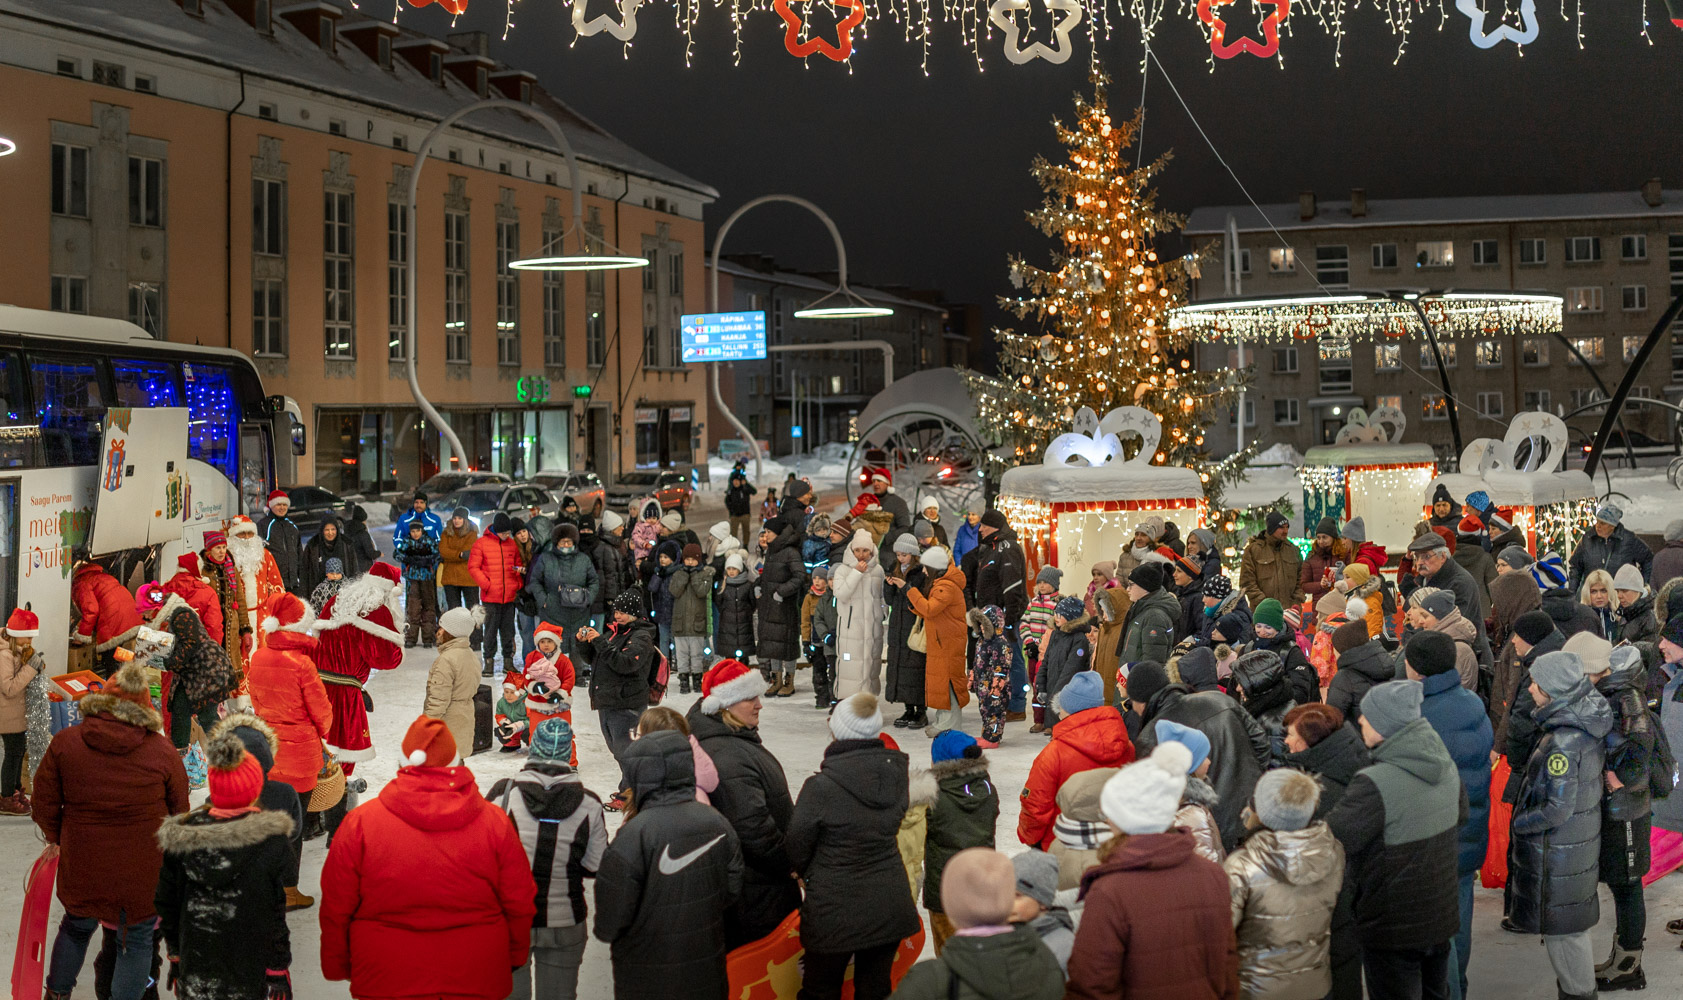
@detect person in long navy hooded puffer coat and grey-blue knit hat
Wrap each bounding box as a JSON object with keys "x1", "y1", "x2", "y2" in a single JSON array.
[{"x1": 1508, "y1": 650, "x2": 1612, "y2": 1000}]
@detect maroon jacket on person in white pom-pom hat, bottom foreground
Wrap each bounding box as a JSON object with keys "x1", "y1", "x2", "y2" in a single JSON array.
[{"x1": 1064, "y1": 828, "x2": 1239, "y2": 1000}]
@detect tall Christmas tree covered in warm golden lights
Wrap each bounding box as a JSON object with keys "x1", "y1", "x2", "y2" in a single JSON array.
[{"x1": 969, "y1": 74, "x2": 1254, "y2": 510}]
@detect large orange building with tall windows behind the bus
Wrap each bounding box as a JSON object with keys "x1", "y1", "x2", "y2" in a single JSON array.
[{"x1": 0, "y1": 0, "x2": 717, "y2": 492}]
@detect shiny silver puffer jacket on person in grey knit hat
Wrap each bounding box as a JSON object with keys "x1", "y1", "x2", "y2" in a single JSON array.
[{"x1": 1224, "y1": 822, "x2": 1345, "y2": 1000}]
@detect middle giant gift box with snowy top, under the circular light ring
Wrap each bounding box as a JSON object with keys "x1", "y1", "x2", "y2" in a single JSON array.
[{"x1": 1298, "y1": 406, "x2": 1437, "y2": 554}]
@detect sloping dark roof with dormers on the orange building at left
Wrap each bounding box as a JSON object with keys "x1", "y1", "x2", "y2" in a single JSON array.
[{"x1": 0, "y1": 0, "x2": 719, "y2": 199}]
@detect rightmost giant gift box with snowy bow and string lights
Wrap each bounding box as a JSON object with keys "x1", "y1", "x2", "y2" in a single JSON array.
[{"x1": 1424, "y1": 411, "x2": 1595, "y2": 556}]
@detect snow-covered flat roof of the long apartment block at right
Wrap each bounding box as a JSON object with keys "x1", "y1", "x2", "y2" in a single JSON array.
[{"x1": 1185, "y1": 190, "x2": 1683, "y2": 236}]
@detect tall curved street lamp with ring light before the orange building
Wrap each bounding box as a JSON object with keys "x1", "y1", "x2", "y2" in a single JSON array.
[{"x1": 404, "y1": 98, "x2": 648, "y2": 463}]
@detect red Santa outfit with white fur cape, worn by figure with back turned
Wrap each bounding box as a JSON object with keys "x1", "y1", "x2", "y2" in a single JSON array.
[{"x1": 315, "y1": 562, "x2": 404, "y2": 774}]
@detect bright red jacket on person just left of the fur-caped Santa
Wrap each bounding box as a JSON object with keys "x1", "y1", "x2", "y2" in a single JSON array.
[{"x1": 246, "y1": 631, "x2": 333, "y2": 795}]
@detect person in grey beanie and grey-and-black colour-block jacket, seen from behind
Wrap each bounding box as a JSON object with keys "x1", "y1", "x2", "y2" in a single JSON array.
[{"x1": 1326, "y1": 680, "x2": 1468, "y2": 1000}]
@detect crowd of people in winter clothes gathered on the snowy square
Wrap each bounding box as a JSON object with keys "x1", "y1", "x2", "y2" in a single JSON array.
[{"x1": 16, "y1": 470, "x2": 1683, "y2": 1000}]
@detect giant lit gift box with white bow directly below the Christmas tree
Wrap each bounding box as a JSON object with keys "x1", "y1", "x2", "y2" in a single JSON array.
[{"x1": 998, "y1": 406, "x2": 1205, "y2": 579}]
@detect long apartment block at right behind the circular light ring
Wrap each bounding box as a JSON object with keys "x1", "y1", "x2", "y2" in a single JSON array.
[{"x1": 1187, "y1": 178, "x2": 1683, "y2": 456}]
